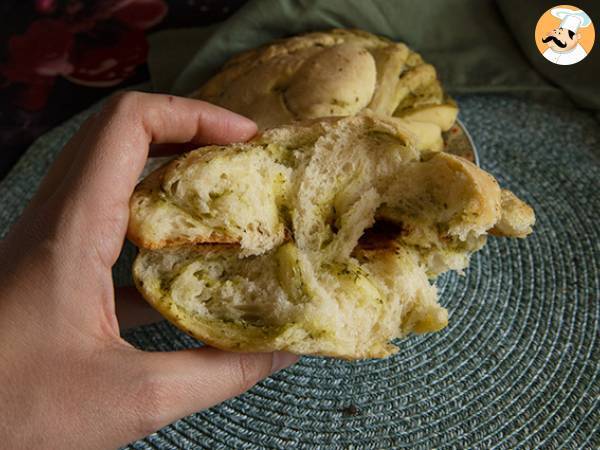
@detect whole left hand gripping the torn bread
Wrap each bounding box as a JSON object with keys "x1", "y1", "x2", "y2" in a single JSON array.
[{"x1": 0, "y1": 92, "x2": 297, "y2": 449}]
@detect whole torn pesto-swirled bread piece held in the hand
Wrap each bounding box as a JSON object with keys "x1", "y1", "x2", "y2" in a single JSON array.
[{"x1": 129, "y1": 114, "x2": 533, "y2": 359}]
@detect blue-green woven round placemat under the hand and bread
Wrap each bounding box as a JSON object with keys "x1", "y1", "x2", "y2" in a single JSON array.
[{"x1": 0, "y1": 96, "x2": 600, "y2": 449}]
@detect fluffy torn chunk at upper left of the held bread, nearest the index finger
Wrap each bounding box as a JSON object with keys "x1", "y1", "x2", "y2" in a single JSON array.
[{"x1": 128, "y1": 144, "x2": 290, "y2": 255}]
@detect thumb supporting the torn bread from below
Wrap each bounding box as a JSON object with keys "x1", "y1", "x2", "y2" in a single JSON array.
[{"x1": 126, "y1": 347, "x2": 299, "y2": 435}]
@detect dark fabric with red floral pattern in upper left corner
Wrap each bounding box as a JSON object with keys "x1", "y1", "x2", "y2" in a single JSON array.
[{"x1": 0, "y1": 0, "x2": 244, "y2": 177}]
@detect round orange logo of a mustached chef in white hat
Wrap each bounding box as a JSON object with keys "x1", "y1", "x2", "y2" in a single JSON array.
[{"x1": 535, "y1": 5, "x2": 595, "y2": 66}]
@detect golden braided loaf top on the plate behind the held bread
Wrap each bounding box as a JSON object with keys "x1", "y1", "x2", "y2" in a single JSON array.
[{"x1": 191, "y1": 29, "x2": 447, "y2": 129}]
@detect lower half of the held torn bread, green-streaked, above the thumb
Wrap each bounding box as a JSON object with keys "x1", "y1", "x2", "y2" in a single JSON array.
[{"x1": 133, "y1": 242, "x2": 448, "y2": 359}]
